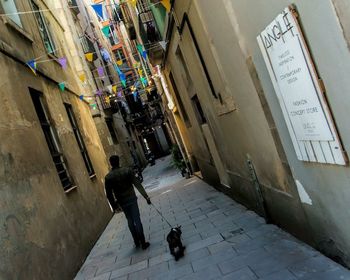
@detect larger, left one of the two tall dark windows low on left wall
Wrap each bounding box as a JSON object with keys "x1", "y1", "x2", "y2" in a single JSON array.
[{"x1": 29, "y1": 89, "x2": 73, "y2": 191}]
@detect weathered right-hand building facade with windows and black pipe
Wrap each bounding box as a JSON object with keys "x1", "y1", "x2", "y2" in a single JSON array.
[{"x1": 163, "y1": 0, "x2": 350, "y2": 265}]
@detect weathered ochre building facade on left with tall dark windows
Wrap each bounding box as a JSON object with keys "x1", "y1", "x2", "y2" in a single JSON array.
[{"x1": 0, "y1": 0, "x2": 111, "y2": 280}]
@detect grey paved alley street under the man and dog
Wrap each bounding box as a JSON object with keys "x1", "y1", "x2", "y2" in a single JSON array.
[{"x1": 75, "y1": 158, "x2": 350, "y2": 280}]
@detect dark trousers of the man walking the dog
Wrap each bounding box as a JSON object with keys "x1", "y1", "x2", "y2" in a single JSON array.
[{"x1": 121, "y1": 200, "x2": 145, "y2": 246}]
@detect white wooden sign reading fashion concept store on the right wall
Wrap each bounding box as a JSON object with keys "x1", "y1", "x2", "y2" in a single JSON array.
[{"x1": 258, "y1": 8, "x2": 346, "y2": 164}]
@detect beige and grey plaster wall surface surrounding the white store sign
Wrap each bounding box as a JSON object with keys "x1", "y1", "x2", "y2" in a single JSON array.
[{"x1": 166, "y1": 0, "x2": 350, "y2": 265}]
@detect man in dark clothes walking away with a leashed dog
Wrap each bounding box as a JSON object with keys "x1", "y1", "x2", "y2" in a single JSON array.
[{"x1": 105, "y1": 156, "x2": 151, "y2": 250}]
